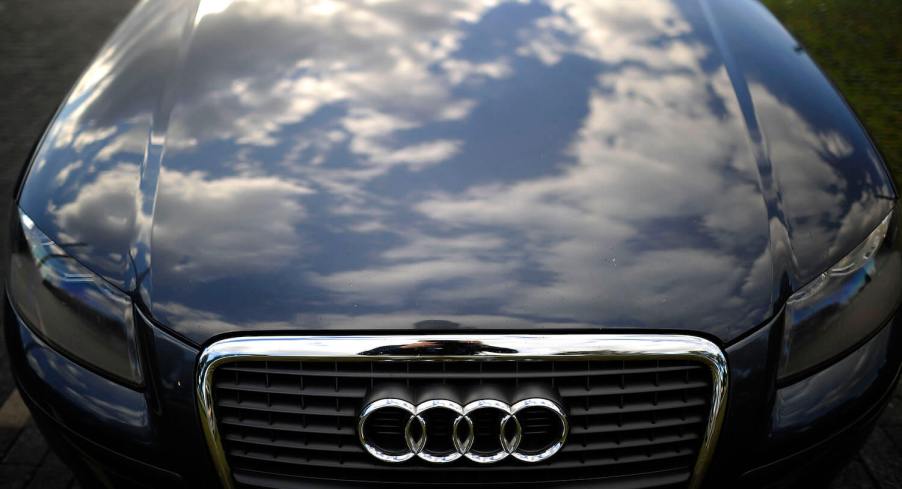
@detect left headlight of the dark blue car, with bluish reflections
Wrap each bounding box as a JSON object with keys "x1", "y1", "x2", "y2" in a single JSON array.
[{"x1": 9, "y1": 211, "x2": 142, "y2": 384}]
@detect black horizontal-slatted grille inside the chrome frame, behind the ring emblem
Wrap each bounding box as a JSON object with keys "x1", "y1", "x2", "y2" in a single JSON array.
[{"x1": 212, "y1": 352, "x2": 715, "y2": 488}]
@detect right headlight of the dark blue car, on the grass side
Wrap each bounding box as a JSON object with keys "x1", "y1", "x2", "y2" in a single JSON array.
[{"x1": 779, "y1": 208, "x2": 902, "y2": 380}]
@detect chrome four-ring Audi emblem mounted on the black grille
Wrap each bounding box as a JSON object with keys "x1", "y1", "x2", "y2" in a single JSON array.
[{"x1": 357, "y1": 398, "x2": 569, "y2": 464}]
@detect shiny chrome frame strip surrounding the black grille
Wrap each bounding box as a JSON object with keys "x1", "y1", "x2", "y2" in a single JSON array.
[{"x1": 196, "y1": 334, "x2": 729, "y2": 489}]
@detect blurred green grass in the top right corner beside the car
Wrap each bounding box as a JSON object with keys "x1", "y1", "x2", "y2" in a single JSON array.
[{"x1": 763, "y1": 0, "x2": 902, "y2": 188}]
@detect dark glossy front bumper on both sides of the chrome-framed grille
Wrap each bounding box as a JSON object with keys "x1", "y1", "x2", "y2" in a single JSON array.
[{"x1": 4, "y1": 296, "x2": 902, "y2": 488}]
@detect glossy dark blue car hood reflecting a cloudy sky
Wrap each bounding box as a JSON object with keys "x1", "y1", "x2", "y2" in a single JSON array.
[{"x1": 20, "y1": 0, "x2": 894, "y2": 344}]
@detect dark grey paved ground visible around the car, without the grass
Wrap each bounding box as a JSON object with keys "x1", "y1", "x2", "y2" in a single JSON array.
[{"x1": 0, "y1": 0, "x2": 902, "y2": 489}]
